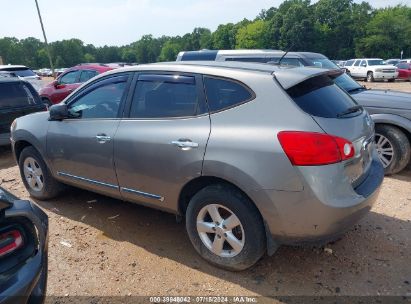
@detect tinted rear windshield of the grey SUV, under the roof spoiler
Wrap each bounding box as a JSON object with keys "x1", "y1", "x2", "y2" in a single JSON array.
[{"x1": 287, "y1": 75, "x2": 358, "y2": 118}]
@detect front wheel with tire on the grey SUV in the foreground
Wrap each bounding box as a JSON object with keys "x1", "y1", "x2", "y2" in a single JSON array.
[{"x1": 19, "y1": 147, "x2": 64, "y2": 200}]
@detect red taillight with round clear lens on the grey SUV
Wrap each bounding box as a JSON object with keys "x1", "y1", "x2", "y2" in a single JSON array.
[{"x1": 277, "y1": 131, "x2": 355, "y2": 166}]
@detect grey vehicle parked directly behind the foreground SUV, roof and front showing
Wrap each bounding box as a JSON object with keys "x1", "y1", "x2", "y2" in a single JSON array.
[{"x1": 177, "y1": 50, "x2": 411, "y2": 174}]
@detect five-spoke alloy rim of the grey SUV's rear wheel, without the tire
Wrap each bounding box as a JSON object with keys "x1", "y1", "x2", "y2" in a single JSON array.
[{"x1": 197, "y1": 204, "x2": 245, "y2": 257}]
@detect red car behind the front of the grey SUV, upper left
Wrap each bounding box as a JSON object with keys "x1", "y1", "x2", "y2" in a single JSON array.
[{"x1": 39, "y1": 63, "x2": 113, "y2": 105}]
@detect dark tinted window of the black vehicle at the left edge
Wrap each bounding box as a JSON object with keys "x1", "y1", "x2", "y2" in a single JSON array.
[{"x1": 0, "y1": 82, "x2": 41, "y2": 109}]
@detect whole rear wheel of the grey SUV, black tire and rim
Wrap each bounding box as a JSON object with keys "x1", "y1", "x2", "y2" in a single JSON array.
[{"x1": 186, "y1": 184, "x2": 266, "y2": 271}]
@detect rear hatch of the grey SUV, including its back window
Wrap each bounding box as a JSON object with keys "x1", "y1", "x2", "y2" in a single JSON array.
[{"x1": 277, "y1": 71, "x2": 374, "y2": 188}]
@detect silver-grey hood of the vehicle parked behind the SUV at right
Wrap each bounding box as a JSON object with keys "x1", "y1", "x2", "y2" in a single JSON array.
[{"x1": 351, "y1": 90, "x2": 411, "y2": 110}]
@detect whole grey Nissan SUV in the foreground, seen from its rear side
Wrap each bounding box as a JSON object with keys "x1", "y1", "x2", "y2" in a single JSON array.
[{"x1": 12, "y1": 62, "x2": 383, "y2": 270}]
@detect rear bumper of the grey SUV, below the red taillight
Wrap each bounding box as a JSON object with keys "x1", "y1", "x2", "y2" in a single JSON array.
[{"x1": 259, "y1": 159, "x2": 384, "y2": 244}]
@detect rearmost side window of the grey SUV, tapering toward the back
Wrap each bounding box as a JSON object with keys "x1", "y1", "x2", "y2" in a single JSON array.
[{"x1": 204, "y1": 76, "x2": 255, "y2": 112}]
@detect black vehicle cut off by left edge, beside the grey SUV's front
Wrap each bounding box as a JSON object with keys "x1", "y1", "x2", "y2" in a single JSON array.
[{"x1": 0, "y1": 77, "x2": 47, "y2": 146}]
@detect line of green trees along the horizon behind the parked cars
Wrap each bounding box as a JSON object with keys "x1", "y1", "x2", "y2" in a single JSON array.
[{"x1": 0, "y1": 0, "x2": 411, "y2": 69}]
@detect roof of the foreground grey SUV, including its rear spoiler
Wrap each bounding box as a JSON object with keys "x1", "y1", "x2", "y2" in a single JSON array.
[{"x1": 100, "y1": 61, "x2": 342, "y2": 89}]
